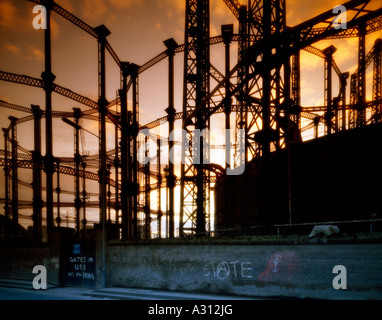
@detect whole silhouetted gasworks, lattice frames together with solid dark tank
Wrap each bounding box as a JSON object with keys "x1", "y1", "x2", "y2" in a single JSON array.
[{"x1": 0, "y1": 0, "x2": 382, "y2": 242}]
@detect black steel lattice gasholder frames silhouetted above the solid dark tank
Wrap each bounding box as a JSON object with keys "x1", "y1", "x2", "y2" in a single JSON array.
[{"x1": 0, "y1": 0, "x2": 382, "y2": 241}]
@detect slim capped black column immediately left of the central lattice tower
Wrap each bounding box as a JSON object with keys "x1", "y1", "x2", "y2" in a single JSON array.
[{"x1": 164, "y1": 38, "x2": 178, "y2": 238}]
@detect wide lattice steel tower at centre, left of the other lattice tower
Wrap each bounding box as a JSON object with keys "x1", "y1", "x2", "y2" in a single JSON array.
[{"x1": 180, "y1": 0, "x2": 210, "y2": 234}]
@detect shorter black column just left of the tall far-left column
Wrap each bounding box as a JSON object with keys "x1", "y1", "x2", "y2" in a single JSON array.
[{"x1": 32, "y1": 105, "x2": 42, "y2": 242}]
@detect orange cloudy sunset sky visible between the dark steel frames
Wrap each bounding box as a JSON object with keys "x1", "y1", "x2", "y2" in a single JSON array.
[{"x1": 0, "y1": 0, "x2": 382, "y2": 230}]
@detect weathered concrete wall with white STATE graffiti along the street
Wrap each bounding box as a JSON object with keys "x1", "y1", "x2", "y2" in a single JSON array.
[{"x1": 106, "y1": 244, "x2": 382, "y2": 299}]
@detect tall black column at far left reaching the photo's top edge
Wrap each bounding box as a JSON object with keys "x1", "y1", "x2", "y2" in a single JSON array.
[{"x1": 41, "y1": 0, "x2": 56, "y2": 237}]
